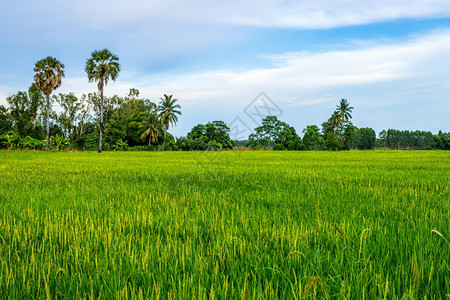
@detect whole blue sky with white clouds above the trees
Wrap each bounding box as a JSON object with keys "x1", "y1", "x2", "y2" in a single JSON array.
[{"x1": 0, "y1": 0, "x2": 450, "y2": 136}]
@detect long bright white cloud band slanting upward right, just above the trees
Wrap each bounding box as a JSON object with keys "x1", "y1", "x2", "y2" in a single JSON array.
[{"x1": 111, "y1": 31, "x2": 450, "y2": 104}]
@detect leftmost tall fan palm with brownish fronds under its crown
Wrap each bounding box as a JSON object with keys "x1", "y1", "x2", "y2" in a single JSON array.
[{"x1": 34, "y1": 56, "x2": 64, "y2": 150}]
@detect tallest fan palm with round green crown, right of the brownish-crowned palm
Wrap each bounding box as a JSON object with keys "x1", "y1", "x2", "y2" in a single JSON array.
[{"x1": 84, "y1": 49, "x2": 120, "y2": 153}]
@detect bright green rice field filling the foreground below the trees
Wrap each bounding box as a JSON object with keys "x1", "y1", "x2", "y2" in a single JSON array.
[{"x1": 0, "y1": 151, "x2": 450, "y2": 299}]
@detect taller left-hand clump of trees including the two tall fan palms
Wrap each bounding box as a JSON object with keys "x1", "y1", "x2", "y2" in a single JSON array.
[{"x1": 0, "y1": 49, "x2": 181, "y2": 153}]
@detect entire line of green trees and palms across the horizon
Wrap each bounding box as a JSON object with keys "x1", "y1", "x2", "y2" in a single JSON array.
[{"x1": 0, "y1": 49, "x2": 450, "y2": 152}]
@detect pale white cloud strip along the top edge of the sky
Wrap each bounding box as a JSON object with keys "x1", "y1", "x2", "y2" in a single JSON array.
[{"x1": 4, "y1": 0, "x2": 450, "y2": 31}]
